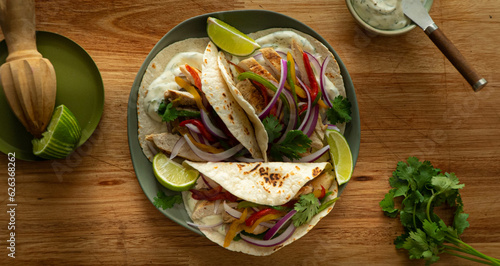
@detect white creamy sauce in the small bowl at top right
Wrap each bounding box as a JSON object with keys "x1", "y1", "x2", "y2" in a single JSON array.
[{"x1": 352, "y1": 0, "x2": 425, "y2": 30}]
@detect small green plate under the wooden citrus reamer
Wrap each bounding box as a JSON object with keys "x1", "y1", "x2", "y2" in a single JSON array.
[{"x1": 0, "y1": 31, "x2": 104, "y2": 161}]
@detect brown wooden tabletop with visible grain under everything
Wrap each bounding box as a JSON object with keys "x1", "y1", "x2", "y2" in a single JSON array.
[{"x1": 0, "y1": 0, "x2": 500, "y2": 265}]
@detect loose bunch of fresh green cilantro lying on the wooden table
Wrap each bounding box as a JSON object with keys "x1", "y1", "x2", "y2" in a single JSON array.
[{"x1": 380, "y1": 157, "x2": 500, "y2": 265}]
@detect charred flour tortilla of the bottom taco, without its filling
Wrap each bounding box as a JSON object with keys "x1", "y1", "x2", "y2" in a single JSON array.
[{"x1": 182, "y1": 161, "x2": 338, "y2": 256}]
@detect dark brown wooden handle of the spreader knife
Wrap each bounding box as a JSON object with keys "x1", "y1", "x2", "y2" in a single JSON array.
[{"x1": 429, "y1": 28, "x2": 487, "y2": 91}]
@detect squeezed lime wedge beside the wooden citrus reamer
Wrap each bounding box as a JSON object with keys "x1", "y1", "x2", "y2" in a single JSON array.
[{"x1": 31, "y1": 105, "x2": 82, "y2": 159}]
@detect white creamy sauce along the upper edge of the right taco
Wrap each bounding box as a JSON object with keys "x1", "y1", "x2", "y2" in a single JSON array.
[{"x1": 250, "y1": 31, "x2": 339, "y2": 95}]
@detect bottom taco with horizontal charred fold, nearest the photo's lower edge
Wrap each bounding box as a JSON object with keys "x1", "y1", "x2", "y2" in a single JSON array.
[{"x1": 182, "y1": 161, "x2": 338, "y2": 256}]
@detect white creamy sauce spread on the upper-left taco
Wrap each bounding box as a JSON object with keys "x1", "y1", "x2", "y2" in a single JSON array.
[{"x1": 144, "y1": 52, "x2": 203, "y2": 122}]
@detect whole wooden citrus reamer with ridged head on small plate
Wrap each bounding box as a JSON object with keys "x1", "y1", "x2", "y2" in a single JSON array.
[{"x1": 0, "y1": 0, "x2": 56, "y2": 138}]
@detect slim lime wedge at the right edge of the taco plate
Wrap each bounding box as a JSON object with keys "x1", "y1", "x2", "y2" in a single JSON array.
[{"x1": 326, "y1": 129, "x2": 353, "y2": 185}]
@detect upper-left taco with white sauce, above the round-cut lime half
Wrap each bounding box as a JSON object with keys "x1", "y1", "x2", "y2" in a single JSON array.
[{"x1": 137, "y1": 38, "x2": 262, "y2": 161}]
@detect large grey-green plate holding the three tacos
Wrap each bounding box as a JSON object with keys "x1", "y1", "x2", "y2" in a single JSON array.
[{"x1": 127, "y1": 10, "x2": 361, "y2": 234}]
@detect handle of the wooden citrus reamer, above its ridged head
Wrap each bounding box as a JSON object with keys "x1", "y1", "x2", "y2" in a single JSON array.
[{"x1": 0, "y1": 0, "x2": 42, "y2": 62}]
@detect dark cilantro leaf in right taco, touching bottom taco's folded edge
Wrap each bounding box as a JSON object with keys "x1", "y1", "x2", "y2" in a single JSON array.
[{"x1": 270, "y1": 130, "x2": 312, "y2": 161}]
